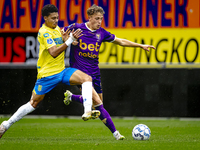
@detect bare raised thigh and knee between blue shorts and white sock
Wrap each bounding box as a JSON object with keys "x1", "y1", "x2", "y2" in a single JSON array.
[{"x1": 69, "y1": 70, "x2": 92, "y2": 85}]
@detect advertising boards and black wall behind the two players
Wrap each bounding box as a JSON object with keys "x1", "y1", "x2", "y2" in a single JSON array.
[{"x1": 0, "y1": 0, "x2": 200, "y2": 117}]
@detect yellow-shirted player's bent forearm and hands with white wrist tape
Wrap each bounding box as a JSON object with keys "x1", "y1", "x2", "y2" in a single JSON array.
[{"x1": 48, "y1": 29, "x2": 83, "y2": 58}]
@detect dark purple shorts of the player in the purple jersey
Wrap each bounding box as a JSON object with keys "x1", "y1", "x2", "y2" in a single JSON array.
[{"x1": 78, "y1": 75, "x2": 102, "y2": 94}]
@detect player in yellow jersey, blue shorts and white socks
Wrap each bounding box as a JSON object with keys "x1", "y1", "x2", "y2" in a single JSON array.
[{"x1": 0, "y1": 4, "x2": 101, "y2": 138}]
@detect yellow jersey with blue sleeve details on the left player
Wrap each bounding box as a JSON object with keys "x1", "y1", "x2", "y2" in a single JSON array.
[{"x1": 37, "y1": 24, "x2": 65, "y2": 79}]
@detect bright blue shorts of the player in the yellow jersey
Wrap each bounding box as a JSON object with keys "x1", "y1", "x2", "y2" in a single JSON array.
[{"x1": 33, "y1": 67, "x2": 78, "y2": 95}]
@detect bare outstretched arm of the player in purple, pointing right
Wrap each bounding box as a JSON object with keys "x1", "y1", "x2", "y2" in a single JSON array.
[{"x1": 113, "y1": 37, "x2": 156, "y2": 51}]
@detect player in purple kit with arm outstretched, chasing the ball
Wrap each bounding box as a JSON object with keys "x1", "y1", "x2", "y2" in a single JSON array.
[{"x1": 63, "y1": 4, "x2": 155, "y2": 140}]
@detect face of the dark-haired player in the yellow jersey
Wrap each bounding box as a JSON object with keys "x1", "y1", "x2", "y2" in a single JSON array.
[{"x1": 44, "y1": 12, "x2": 59, "y2": 29}]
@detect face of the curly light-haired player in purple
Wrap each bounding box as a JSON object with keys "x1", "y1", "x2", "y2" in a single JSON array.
[{"x1": 89, "y1": 12, "x2": 103, "y2": 30}]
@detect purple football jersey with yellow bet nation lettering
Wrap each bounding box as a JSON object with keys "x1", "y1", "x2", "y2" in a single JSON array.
[{"x1": 64, "y1": 23, "x2": 115, "y2": 76}]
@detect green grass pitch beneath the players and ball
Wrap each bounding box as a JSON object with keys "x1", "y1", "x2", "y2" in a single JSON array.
[{"x1": 0, "y1": 118, "x2": 200, "y2": 150}]
